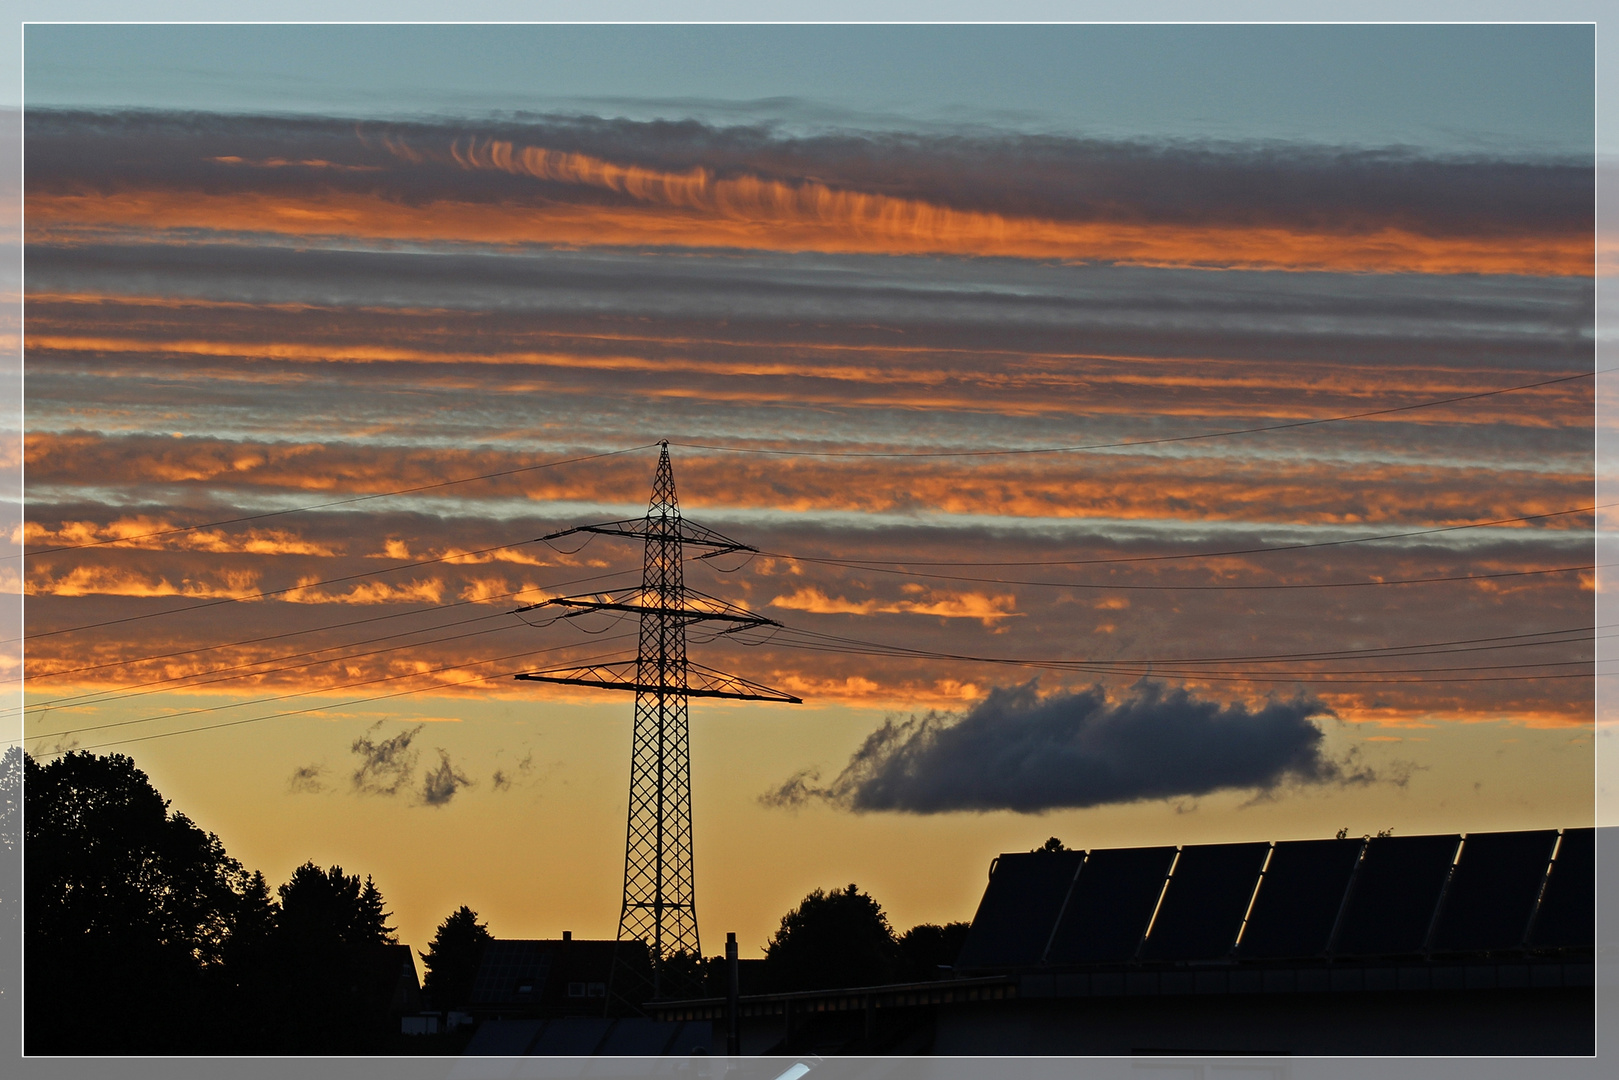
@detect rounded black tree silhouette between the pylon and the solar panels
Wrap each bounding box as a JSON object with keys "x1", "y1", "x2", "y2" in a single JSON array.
[{"x1": 764, "y1": 884, "x2": 897, "y2": 989}]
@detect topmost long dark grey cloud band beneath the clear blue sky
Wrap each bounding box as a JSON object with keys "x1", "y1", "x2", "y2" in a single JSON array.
[{"x1": 24, "y1": 110, "x2": 1595, "y2": 235}]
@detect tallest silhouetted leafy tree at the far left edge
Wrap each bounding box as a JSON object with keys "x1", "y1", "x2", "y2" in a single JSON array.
[{"x1": 24, "y1": 753, "x2": 248, "y2": 1054}]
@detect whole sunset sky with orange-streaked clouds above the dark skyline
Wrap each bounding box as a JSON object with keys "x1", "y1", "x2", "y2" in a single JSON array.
[{"x1": 23, "y1": 26, "x2": 1603, "y2": 955}]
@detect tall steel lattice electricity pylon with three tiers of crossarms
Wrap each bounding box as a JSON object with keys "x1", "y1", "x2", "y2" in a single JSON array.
[{"x1": 518, "y1": 442, "x2": 801, "y2": 1006}]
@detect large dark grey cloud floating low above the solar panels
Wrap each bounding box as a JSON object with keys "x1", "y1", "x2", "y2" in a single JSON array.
[{"x1": 761, "y1": 680, "x2": 1375, "y2": 814}]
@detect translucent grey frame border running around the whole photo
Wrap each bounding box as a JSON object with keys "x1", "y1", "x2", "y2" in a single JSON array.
[{"x1": 0, "y1": 8, "x2": 1619, "y2": 1080}]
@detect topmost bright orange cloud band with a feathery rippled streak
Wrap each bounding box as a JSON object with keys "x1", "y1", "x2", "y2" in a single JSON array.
[{"x1": 28, "y1": 176, "x2": 1593, "y2": 275}]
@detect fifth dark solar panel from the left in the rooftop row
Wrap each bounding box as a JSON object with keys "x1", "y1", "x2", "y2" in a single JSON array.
[{"x1": 1331, "y1": 836, "x2": 1462, "y2": 957}]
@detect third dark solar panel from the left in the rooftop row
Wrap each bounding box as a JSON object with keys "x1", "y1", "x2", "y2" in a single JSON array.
[{"x1": 1141, "y1": 844, "x2": 1271, "y2": 960}]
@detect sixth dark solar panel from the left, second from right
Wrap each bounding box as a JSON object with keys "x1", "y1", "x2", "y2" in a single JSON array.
[{"x1": 1428, "y1": 829, "x2": 1557, "y2": 952}]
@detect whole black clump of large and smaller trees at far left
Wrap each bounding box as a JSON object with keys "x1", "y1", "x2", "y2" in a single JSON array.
[{"x1": 25, "y1": 753, "x2": 411, "y2": 1054}]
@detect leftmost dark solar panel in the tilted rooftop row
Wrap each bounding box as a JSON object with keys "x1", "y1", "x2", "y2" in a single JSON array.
[{"x1": 955, "y1": 852, "x2": 1085, "y2": 968}]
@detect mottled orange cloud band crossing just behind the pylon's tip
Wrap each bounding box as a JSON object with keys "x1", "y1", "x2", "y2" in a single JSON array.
[{"x1": 28, "y1": 432, "x2": 1590, "y2": 531}]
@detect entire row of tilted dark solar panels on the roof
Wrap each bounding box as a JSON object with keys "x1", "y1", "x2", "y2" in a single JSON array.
[{"x1": 955, "y1": 829, "x2": 1596, "y2": 970}]
